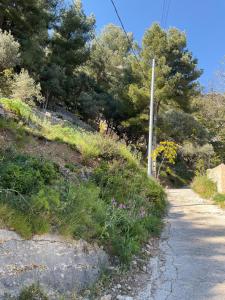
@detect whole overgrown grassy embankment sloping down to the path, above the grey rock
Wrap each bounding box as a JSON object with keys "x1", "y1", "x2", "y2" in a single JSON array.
[{"x1": 0, "y1": 99, "x2": 166, "y2": 263}]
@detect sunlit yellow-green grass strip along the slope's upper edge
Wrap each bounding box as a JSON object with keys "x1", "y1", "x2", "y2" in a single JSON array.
[{"x1": 0, "y1": 98, "x2": 139, "y2": 164}]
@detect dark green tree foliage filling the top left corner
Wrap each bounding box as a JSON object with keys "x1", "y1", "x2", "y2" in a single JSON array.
[{"x1": 0, "y1": 0, "x2": 59, "y2": 75}]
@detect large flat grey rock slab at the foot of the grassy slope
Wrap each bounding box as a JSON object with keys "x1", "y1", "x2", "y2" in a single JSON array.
[{"x1": 0, "y1": 230, "x2": 109, "y2": 300}]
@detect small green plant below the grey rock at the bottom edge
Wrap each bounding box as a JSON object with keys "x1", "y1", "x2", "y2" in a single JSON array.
[{"x1": 17, "y1": 284, "x2": 48, "y2": 300}]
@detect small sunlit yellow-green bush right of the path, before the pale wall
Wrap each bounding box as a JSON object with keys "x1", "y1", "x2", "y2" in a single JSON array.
[{"x1": 191, "y1": 176, "x2": 217, "y2": 199}]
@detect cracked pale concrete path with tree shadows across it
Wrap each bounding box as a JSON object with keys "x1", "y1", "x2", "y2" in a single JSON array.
[{"x1": 135, "y1": 189, "x2": 225, "y2": 300}]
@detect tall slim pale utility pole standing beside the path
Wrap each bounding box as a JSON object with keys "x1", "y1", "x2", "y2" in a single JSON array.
[{"x1": 148, "y1": 58, "x2": 155, "y2": 177}]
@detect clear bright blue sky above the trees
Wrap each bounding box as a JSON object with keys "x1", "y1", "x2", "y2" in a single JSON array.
[{"x1": 79, "y1": 0, "x2": 225, "y2": 90}]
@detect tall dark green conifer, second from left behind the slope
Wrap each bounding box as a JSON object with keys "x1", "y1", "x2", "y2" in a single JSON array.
[{"x1": 41, "y1": 1, "x2": 95, "y2": 109}]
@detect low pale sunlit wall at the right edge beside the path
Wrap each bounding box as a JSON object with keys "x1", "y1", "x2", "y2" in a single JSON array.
[{"x1": 207, "y1": 164, "x2": 225, "y2": 193}]
